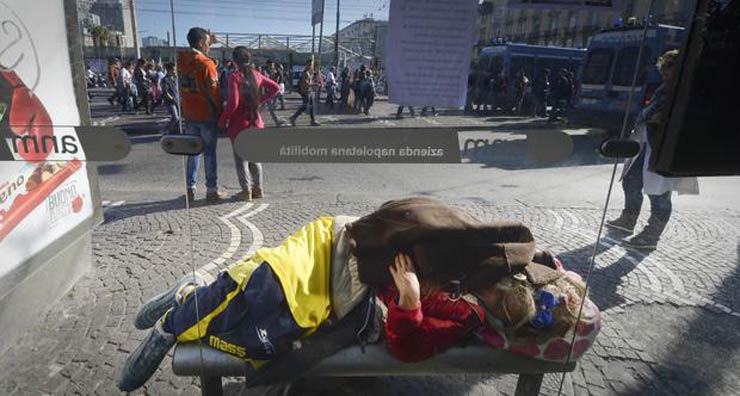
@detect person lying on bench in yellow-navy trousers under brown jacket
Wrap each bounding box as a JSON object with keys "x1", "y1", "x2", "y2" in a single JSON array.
[{"x1": 118, "y1": 198, "x2": 591, "y2": 391}]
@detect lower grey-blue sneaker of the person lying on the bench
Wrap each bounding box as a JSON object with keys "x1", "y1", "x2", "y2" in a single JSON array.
[{"x1": 118, "y1": 321, "x2": 176, "y2": 392}]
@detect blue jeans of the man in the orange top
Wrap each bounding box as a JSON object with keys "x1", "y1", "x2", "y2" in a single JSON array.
[{"x1": 185, "y1": 121, "x2": 218, "y2": 192}]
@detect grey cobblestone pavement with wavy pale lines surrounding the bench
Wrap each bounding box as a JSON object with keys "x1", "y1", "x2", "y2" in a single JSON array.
[{"x1": 0, "y1": 193, "x2": 740, "y2": 395}]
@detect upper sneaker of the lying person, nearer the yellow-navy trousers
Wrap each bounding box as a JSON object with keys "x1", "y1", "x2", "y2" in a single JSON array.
[{"x1": 134, "y1": 272, "x2": 208, "y2": 330}]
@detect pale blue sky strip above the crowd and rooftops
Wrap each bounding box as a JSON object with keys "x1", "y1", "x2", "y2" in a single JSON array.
[{"x1": 136, "y1": 0, "x2": 389, "y2": 45}]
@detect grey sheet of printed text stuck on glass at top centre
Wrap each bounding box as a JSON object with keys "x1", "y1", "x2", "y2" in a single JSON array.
[{"x1": 386, "y1": 0, "x2": 478, "y2": 107}]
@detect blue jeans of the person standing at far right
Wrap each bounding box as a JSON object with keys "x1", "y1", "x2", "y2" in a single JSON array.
[{"x1": 622, "y1": 148, "x2": 673, "y2": 226}]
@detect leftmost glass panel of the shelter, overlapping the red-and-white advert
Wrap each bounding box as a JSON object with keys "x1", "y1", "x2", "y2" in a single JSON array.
[{"x1": 0, "y1": 0, "x2": 197, "y2": 395}]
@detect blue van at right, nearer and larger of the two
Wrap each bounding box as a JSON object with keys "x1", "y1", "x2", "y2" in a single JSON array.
[{"x1": 569, "y1": 25, "x2": 685, "y2": 135}]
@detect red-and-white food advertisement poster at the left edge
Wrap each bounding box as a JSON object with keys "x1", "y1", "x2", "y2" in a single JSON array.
[{"x1": 0, "y1": 0, "x2": 93, "y2": 278}]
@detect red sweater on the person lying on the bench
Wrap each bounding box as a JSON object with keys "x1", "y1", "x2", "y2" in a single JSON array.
[{"x1": 381, "y1": 286, "x2": 485, "y2": 362}]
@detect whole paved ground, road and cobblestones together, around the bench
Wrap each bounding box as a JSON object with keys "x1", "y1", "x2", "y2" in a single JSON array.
[{"x1": 0, "y1": 96, "x2": 740, "y2": 396}]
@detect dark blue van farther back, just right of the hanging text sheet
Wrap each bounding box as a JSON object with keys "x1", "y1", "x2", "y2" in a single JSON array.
[{"x1": 475, "y1": 43, "x2": 586, "y2": 109}]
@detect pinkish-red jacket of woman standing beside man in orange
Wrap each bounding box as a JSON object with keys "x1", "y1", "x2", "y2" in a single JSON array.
[{"x1": 218, "y1": 70, "x2": 280, "y2": 140}]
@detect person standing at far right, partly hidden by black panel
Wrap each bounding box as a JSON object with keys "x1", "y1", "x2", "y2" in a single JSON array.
[{"x1": 606, "y1": 50, "x2": 699, "y2": 250}]
